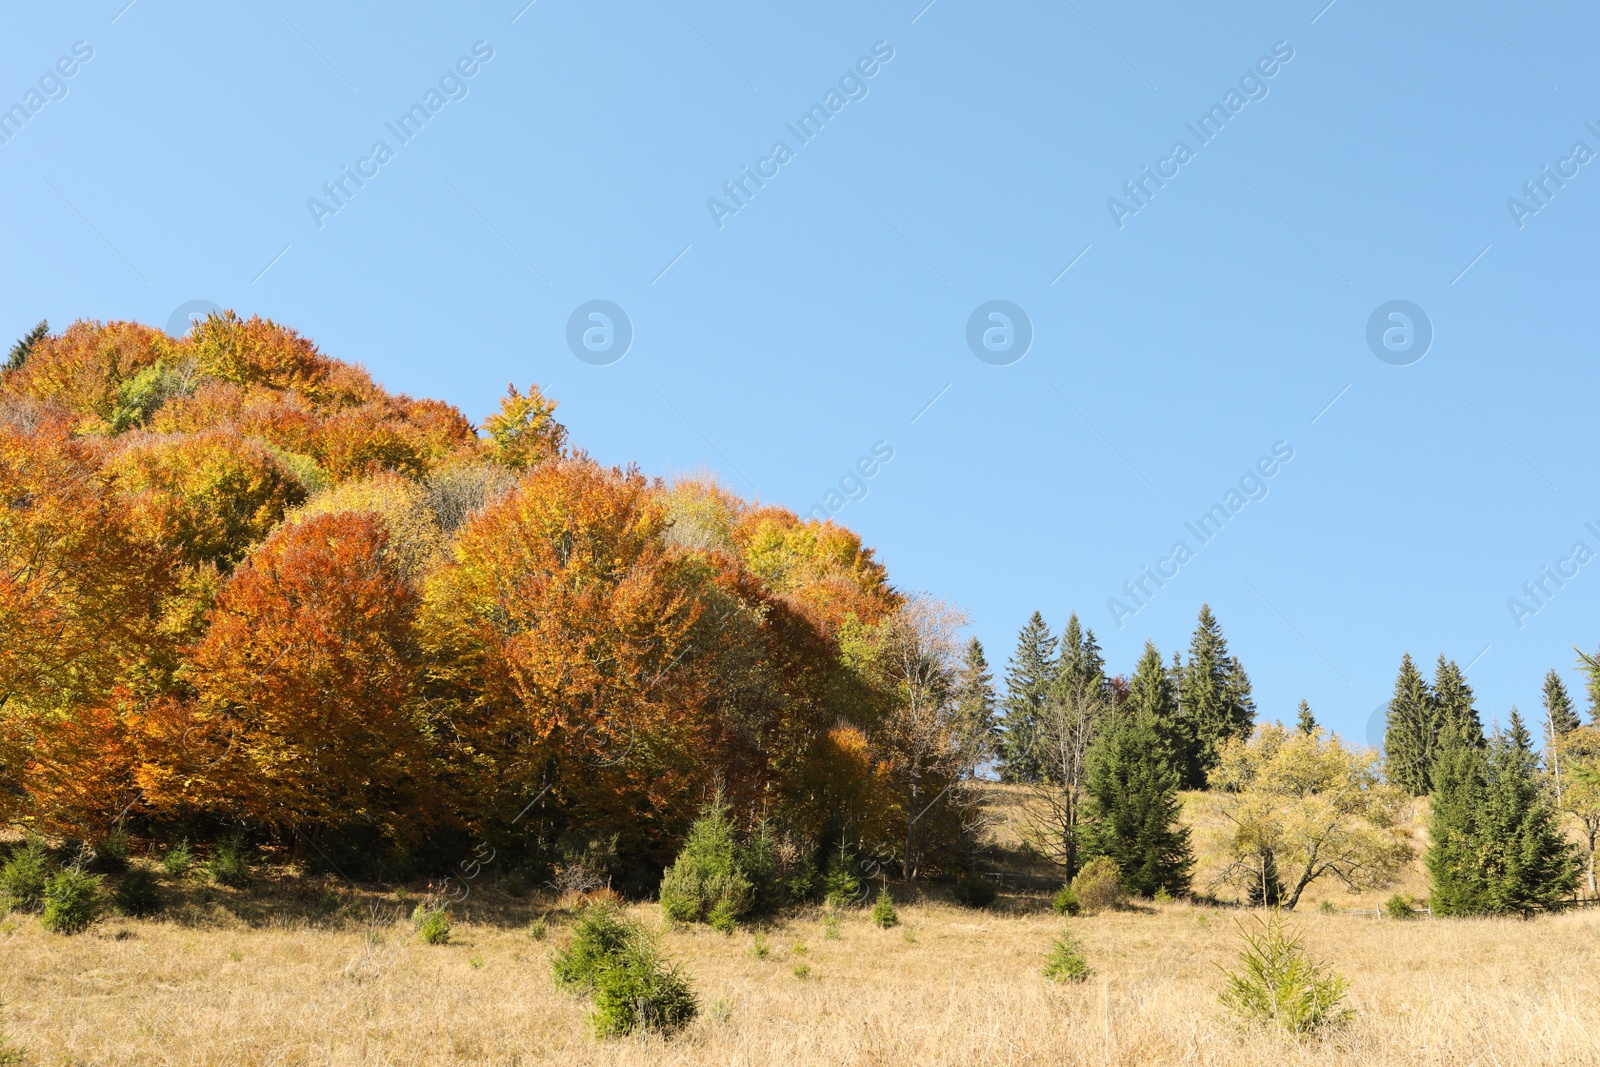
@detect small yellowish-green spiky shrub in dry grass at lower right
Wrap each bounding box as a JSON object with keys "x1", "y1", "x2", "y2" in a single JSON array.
[{"x1": 1221, "y1": 913, "x2": 1350, "y2": 1033}]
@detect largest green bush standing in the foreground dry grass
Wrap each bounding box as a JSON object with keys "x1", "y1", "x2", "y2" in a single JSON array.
[{"x1": 550, "y1": 904, "x2": 699, "y2": 1037}]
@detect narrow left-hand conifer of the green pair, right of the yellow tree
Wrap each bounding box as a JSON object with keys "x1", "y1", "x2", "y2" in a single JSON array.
[{"x1": 1427, "y1": 703, "x2": 1490, "y2": 915}]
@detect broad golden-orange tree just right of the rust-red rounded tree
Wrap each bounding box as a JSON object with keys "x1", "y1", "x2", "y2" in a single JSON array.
[{"x1": 426, "y1": 461, "x2": 722, "y2": 848}]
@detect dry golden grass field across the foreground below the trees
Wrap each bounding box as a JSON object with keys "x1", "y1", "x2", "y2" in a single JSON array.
[{"x1": 0, "y1": 783, "x2": 1600, "y2": 1067}]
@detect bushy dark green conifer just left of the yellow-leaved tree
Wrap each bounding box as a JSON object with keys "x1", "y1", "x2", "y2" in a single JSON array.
[{"x1": 1083, "y1": 713, "x2": 1194, "y2": 897}]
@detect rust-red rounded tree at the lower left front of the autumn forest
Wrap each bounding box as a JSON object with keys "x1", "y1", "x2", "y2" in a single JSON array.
[{"x1": 141, "y1": 512, "x2": 430, "y2": 841}]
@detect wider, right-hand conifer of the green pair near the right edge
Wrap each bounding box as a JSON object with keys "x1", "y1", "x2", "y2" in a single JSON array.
[{"x1": 1482, "y1": 707, "x2": 1578, "y2": 915}]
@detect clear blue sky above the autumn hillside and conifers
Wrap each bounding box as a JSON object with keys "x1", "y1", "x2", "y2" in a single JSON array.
[{"x1": 0, "y1": 0, "x2": 1600, "y2": 748}]
